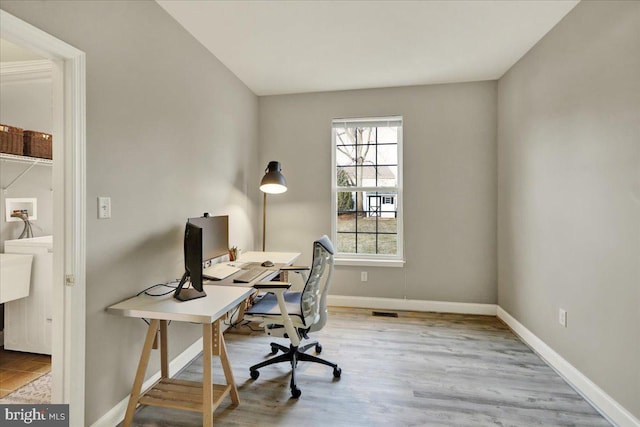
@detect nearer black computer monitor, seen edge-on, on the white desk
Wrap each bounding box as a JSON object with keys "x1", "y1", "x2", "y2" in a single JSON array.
[{"x1": 173, "y1": 222, "x2": 207, "y2": 301}]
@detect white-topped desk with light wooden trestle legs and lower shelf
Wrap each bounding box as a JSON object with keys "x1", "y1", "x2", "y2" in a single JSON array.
[{"x1": 107, "y1": 252, "x2": 300, "y2": 427}]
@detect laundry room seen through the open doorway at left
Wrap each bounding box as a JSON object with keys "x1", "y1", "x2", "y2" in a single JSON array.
[{"x1": 0, "y1": 48, "x2": 53, "y2": 403}]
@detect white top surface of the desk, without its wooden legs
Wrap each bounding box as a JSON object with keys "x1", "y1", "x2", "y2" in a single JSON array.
[{"x1": 107, "y1": 252, "x2": 300, "y2": 323}]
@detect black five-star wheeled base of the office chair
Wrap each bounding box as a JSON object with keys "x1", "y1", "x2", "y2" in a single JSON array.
[{"x1": 249, "y1": 341, "x2": 342, "y2": 399}]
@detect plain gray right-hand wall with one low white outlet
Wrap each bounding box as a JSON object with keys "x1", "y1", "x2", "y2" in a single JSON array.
[{"x1": 498, "y1": 1, "x2": 640, "y2": 418}]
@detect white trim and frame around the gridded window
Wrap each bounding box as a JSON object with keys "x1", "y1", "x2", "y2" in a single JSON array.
[{"x1": 331, "y1": 116, "x2": 406, "y2": 267}]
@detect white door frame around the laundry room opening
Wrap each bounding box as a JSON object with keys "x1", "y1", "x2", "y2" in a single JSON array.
[{"x1": 0, "y1": 10, "x2": 86, "y2": 425}]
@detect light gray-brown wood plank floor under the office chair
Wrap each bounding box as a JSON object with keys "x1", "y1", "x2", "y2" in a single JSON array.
[{"x1": 125, "y1": 309, "x2": 610, "y2": 427}]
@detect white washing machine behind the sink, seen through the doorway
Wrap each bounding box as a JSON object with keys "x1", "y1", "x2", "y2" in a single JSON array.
[{"x1": 4, "y1": 236, "x2": 53, "y2": 354}]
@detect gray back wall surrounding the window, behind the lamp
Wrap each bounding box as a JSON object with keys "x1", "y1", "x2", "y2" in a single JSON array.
[{"x1": 260, "y1": 82, "x2": 497, "y2": 303}]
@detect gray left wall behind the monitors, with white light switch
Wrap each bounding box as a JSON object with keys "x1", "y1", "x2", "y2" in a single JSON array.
[{"x1": 2, "y1": 0, "x2": 260, "y2": 424}]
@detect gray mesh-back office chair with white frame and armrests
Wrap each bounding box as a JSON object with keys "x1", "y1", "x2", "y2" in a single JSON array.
[{"x1": 245, "y1": 236, "x2": 342, "y2": 398}]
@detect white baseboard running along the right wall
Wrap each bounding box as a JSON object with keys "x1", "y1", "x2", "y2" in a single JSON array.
[{"x1": 497, "y1": 306, "x2": 640, "y2": 427}]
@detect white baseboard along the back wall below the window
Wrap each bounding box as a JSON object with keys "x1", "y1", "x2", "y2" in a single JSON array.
[{"x1": 327, "y1": 295, "x2": 497, "y2": 316}]
